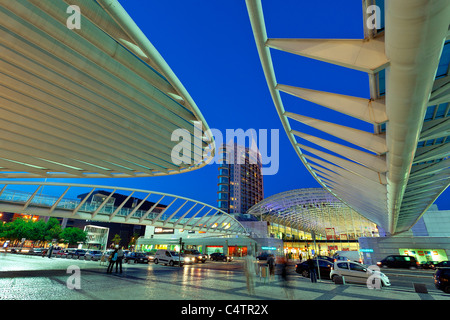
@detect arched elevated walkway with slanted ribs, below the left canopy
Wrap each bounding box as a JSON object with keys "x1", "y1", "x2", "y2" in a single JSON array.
[{"x1": 0, "y1": 181, "x2": 248, "y2": 235}]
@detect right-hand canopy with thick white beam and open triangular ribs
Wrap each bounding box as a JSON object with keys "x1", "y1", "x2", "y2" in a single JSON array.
[{"x1": 246, "y1": 0, "x2": 450, "y2": 234}]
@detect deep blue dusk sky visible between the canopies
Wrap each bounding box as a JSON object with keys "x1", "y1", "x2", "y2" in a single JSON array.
[{"x1": 23, "y1": 0, "x2": 450, "y2": 209}]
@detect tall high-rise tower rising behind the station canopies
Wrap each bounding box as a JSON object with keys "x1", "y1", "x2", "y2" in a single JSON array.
[{"x1": 217, "y1": 142, "x2": 264, "y2": 213}]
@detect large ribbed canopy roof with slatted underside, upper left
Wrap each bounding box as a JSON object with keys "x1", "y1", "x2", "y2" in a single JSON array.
[{"x1": 0, "y1": 0, "x2": 212, "y2": 178}]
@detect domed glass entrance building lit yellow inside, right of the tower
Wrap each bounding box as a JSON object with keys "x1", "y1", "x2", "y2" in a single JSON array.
[{"x1": 248, "y1": 188, "x2": 379, "y2": 257}]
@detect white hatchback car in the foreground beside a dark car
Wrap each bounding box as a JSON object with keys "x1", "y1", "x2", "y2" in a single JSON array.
[{"x1": 330, "y1": 261, "x2": 391, "y2": 289}]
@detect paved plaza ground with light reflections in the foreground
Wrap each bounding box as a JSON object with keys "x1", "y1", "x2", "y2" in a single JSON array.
[{"x1": 0, "y1": 254, "x2": 450, "y2": 301}]
